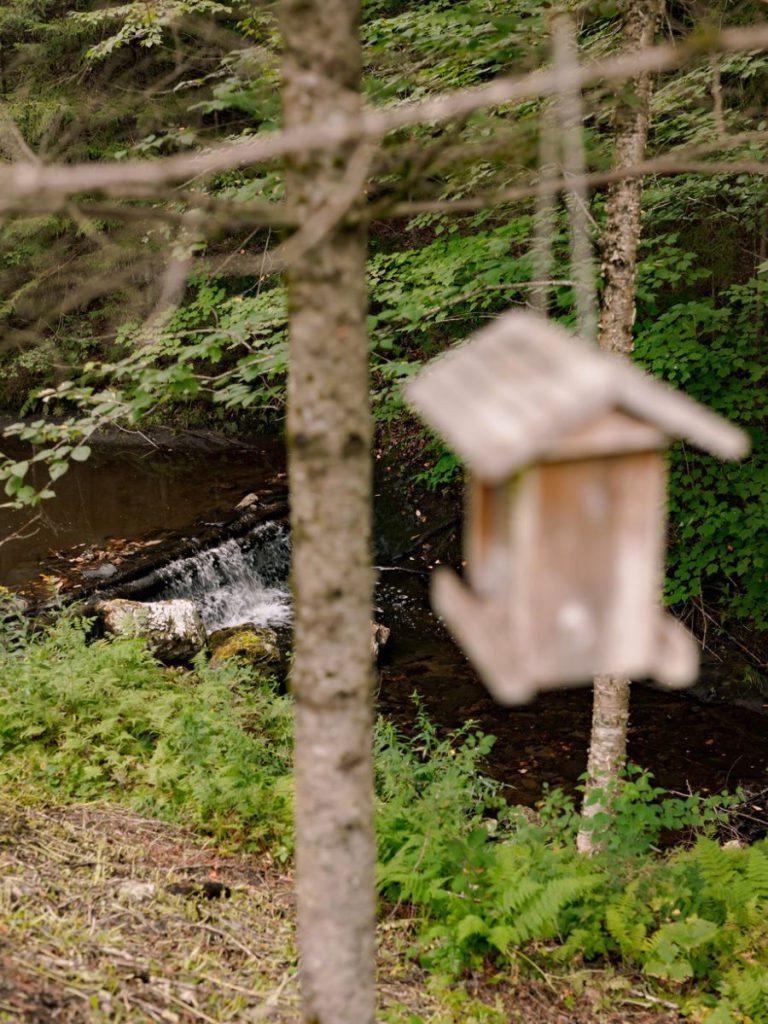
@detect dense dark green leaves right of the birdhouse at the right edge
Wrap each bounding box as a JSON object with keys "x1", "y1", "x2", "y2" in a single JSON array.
[{"x1": 636, "y1": 266, "x2": 768, "y2": 627}]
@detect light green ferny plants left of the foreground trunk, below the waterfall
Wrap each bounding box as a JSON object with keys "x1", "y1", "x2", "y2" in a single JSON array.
[{"x1": 0, "y1": 617, "x2": 291, "y2": 854}]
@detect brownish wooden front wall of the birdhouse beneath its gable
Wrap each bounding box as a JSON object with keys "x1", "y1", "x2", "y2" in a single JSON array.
[{"x1": 507, "y1": 452, "x2": 667, "y2": 684}]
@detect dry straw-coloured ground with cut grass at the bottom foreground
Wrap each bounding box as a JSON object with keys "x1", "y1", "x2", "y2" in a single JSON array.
[{"x1": 0, "y1": 792, "x2": 681, "y2": 1024}]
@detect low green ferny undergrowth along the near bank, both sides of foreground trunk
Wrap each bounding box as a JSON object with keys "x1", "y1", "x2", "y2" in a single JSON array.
[{"x1": 0, "y1": 617, "x2": 768, "y2": 1024}]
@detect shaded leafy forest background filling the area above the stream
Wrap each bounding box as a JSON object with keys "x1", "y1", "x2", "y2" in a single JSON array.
[{"x1": 0, "y1": 0, "x2": 768, "y2": 628}]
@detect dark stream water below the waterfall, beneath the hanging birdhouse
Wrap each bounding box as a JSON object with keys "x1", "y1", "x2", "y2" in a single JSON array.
[{"x1": 379, "y1": 573, "x2": 768, "y2": 802}]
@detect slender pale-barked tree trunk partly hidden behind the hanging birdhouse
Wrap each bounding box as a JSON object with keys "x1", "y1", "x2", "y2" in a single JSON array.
[{"x1": 577, "y1": 0, "x2": 663, "y2": 853}]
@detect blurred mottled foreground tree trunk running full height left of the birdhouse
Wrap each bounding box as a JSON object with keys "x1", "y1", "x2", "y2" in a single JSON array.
[{"x1": 281, "y1": 0, "x2": 375, "y2": 1024}]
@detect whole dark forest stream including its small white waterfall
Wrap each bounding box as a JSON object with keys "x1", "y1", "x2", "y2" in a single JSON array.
[{"x1": 0, "y1": 432, "x2": 768, "y2": 813}]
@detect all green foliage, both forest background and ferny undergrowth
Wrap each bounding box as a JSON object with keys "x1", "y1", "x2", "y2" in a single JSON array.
[{"x1": 0, "y1": 0, "x2": 768, "y2": 1024}]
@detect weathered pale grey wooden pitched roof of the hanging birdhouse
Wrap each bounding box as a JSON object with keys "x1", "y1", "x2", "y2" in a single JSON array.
[{"x1": 406, "y1": 310, "x2": 749, "y2": 483}]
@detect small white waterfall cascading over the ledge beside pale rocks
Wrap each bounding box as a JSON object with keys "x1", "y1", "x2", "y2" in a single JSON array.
[{"x1": 160, "y1": 522, "x2": 291, "y2": 632}]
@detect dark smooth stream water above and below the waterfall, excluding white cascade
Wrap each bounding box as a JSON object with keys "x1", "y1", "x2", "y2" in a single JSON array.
[{"x1": 0, "y1": 435, "x2": 768, "y2": 815}]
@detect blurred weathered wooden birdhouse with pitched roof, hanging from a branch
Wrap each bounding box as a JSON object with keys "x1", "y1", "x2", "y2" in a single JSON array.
[{"x1": 407, "y1": 311, "x2": 749, "y2": 703}]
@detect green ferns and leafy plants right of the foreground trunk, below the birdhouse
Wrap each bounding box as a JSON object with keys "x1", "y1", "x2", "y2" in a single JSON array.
[{"x1": 377, "y1": 718, "x2": 768, "y2": 1024}]
